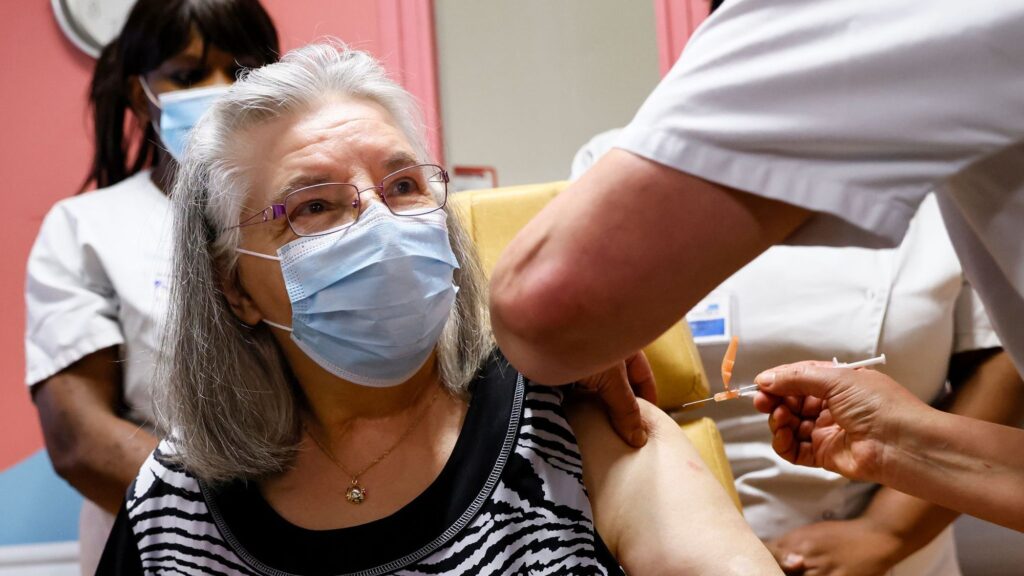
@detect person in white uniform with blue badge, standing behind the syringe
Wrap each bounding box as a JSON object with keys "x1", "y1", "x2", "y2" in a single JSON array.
[{"x1": 571, "y1": 130, "x2": 1024, "y2": 576}]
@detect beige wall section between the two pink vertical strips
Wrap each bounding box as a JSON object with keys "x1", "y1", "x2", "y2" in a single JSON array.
[{"x1": 435, "y1": 0, "x2": 658, "y2": 186}]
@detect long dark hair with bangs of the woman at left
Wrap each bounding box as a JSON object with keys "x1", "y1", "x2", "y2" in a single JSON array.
[{"x1": 83, "y1": 0, "x2": 280, "y2": 190}]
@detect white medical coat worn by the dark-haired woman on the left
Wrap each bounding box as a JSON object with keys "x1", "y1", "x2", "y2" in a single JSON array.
[{"x1": 25, "y1": 171, "x2": 171, "y2": 572}]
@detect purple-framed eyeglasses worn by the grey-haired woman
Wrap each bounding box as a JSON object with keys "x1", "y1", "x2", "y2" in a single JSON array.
[{"x1": 233, "y1": 164, "x2": 449, "y2": 236}]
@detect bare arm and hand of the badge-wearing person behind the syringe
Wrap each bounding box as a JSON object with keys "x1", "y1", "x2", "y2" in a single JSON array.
[{"x1": 768, "y1": 351, "x2": 1024, "y2": 576}]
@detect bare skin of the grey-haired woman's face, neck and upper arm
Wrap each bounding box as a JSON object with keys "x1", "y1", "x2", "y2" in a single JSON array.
[{"x1": 223, "y1": 97, "x2": 778, "y2": 574}]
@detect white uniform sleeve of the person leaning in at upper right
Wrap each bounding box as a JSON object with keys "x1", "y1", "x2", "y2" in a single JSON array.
[{"x1": 617, "y1": 0, "x2": 1024, "y2": 246}]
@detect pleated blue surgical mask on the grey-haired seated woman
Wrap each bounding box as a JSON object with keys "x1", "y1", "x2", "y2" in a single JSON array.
[{"x1": 239, "y1": 202, "x2": 459, "y2": 387}]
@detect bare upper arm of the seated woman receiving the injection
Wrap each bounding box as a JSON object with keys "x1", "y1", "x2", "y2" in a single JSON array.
[{"x1": 567, "y1": 400, "x2": 778, "y2": 574}]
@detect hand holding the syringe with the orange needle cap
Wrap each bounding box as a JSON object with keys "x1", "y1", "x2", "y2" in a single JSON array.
[{"x1": 754, "y1": 362, "x2": 928, "y2": 483}]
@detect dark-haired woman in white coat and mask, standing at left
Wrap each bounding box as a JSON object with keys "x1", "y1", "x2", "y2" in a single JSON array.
[{"x1": 26, "y1": 0, "x2": 279, "y2": 574}]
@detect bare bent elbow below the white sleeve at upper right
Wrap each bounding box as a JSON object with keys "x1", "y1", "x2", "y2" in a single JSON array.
[{"x1": 490, "y1": 150, "x2": 808, "y2": 383}]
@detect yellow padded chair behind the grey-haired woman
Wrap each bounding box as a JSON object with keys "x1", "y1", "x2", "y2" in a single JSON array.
[{"x1": 449, "y1": 182, "x2": 739, "y2": 507}]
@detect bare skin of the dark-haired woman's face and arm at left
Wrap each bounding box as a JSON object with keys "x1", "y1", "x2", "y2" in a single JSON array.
[{"x1": 32, "y1": 34, "x2": 251, "y2": 513}]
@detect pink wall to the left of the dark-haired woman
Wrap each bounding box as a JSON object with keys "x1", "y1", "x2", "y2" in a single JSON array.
[{"x1": 0, "y1": 2, "x2": 91, "y2": 469}]
